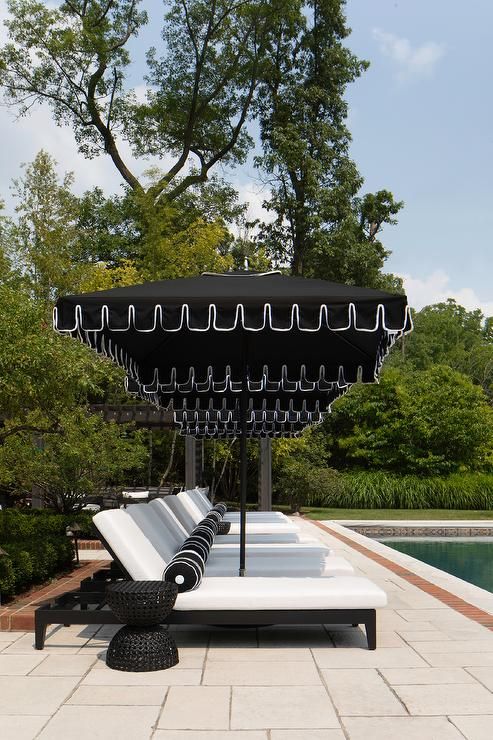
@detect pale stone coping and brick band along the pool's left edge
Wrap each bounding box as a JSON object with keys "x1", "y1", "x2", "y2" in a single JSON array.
[{"x1": 313, "y1": 521, "x2": 493, "y2": 632}]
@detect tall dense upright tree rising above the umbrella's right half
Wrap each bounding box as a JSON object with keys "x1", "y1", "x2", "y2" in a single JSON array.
[{"x1": 257, "y1": 0, "x2": 403, "y2": 287}]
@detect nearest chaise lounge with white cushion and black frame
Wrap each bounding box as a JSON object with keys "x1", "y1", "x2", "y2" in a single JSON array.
[{"x1": 35, "y1": 510, "x2": 387, "y2": 650}]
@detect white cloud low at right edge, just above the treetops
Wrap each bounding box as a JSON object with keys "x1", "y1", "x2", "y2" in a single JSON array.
[{"x1": 401, "y1": 270, "x2": 493, "y2": 316}]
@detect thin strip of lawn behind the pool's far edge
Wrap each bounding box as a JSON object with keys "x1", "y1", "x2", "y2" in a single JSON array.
[{"x1": 301, "y1": 507, "x2": 493, "y2": 520}]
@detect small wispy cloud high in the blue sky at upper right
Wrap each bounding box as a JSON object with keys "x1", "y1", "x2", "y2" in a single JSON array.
[{"x1": 373, "y1": 28, "x2": 445, "y2": 80}]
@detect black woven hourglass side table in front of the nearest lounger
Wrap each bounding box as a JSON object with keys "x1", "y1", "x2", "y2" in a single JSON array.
[{"x1": 106, "y1": 581, "x2": 178, "y2": 671}]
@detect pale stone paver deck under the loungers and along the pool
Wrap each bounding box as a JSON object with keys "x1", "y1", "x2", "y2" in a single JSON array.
[{"x1": 0, "y1": 521, "x2": 493, "y2": 740}]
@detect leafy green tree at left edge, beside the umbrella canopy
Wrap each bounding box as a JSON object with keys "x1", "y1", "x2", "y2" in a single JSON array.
[{"x1": 0, "y1": 280, "x2": 123, "y2": 444}]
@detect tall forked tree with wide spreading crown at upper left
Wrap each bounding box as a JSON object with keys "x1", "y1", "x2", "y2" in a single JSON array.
[{"x1": 0, "y1": 0, "x2": 292, "y2": 204}]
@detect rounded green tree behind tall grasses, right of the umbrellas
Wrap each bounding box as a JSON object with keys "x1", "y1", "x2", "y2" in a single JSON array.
[{"x1": 322, "y1": 365, "x2": 493, "y2": 475}]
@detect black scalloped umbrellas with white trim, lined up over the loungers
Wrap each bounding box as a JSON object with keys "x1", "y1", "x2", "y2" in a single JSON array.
[{"x1": 54, "y1": 272, "x2": 412, "y2": 575}]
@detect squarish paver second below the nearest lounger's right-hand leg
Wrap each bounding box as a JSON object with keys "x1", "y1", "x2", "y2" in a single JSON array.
[{"x1": 322, "y1": 668, "x2": 407, "y2": 717}]
